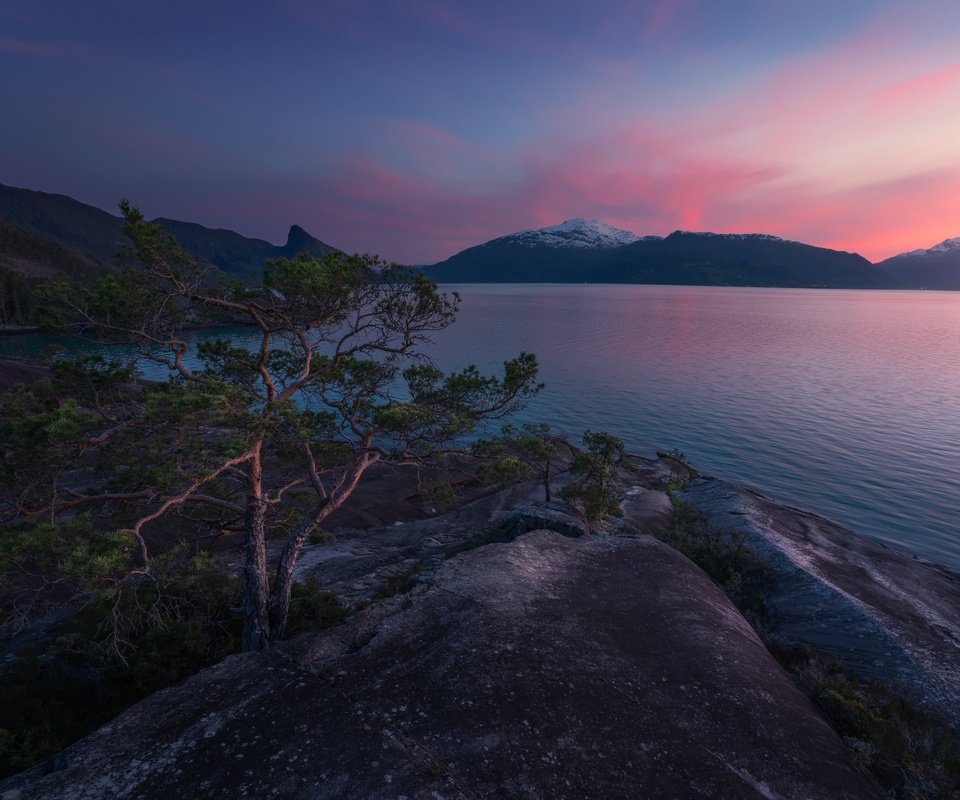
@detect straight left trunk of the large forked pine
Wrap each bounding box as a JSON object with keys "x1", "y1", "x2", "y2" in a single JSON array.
[{"x1": 242, "y1": 443, "x2": 271, "y2": 652}]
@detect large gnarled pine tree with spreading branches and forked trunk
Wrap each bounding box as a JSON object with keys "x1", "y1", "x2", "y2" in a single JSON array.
[{"x1": 6, "y1": 201, "x2": 540, "y2": 650}]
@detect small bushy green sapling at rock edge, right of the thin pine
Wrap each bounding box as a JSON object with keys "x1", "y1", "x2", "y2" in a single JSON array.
[{"x1": 560, "y1": 431, "x2": 623, "y2": 524}]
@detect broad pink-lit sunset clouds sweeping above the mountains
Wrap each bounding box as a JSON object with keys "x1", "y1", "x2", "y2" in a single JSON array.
[{"x1": 86, "y1": 5, "x2": 960, "y2": 263}]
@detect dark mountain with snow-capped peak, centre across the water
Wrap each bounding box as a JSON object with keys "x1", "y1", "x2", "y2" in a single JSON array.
[{"x1": 425, "y1": 219, "x2": 893, "y2": 288}]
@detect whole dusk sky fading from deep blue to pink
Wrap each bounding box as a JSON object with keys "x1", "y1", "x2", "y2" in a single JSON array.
[{"x1": 0, "y1": 0, "x2": 960, "y2": 264}]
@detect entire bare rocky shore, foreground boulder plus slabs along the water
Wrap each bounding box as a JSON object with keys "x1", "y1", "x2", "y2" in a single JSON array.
[{"x1": 0, "y1": 458, "x2": 960, "y2": 800}]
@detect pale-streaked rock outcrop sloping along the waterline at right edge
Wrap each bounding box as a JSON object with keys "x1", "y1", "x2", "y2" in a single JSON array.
[{"x1": 680, "y1": 479, "x2": 960, "y2": 730}]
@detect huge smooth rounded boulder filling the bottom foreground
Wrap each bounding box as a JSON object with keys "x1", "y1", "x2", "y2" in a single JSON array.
[{"x1": 0, "y1": 531, "x2": 877, "y2": 800}]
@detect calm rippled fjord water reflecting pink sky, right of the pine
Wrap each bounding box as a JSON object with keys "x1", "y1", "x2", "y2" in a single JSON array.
[{"x1": 0, "y1": 284, "x2": 960, "y2": 571}]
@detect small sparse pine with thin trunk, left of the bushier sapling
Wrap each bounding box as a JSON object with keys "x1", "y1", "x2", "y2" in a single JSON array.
[{"x1": 473, "y1": 422, "x2": 564, "y2": 503}]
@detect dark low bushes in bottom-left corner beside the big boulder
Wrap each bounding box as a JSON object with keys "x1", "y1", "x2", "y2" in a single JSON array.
[{"x1": 0, "y1": 556, "x2": 239, "y2": 776}]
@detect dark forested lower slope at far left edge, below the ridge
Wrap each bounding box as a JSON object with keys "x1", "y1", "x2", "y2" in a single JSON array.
[{"x1": 0, "y1": 219, "x2": 113, "y2": 325}]
